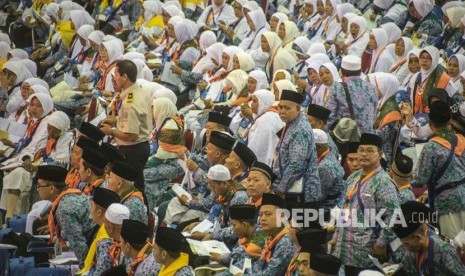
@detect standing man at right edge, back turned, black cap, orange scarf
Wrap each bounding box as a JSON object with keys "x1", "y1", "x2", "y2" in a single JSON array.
[{"x1": 413, "y1": 101, "x2": 465, "y2": 239}]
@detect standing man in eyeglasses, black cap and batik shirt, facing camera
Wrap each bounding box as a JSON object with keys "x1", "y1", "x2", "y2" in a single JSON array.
[{"x1": 330, "y1": 133, "x2": 400, "y2": 276}]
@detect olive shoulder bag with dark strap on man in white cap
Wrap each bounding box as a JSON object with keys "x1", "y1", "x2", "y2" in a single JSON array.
[{"x1": 329, "y1": 82, "x2": 361, "y2": 159}]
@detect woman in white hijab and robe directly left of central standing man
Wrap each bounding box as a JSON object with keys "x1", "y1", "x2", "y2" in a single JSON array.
[{"x1": 244, "y1": 90, "x2": 285, "y2": 166}]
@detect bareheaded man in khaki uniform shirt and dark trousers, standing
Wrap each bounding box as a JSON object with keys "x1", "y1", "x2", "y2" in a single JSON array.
[{"x1": 101, "y1": 60, "x2": 152, "y2": 192}]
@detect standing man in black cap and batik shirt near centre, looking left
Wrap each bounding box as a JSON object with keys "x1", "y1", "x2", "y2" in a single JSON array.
[{"x1": 273, "y1": 90, "x2": 323, "y2": 209}]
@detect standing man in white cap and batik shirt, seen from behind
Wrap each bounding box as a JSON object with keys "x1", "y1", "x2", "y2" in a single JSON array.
[{"x1": 325, "y1": 55, "x2": 378, "y2": 133}]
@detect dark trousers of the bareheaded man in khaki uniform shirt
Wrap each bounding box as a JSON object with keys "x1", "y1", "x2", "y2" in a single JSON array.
[{"x1": 118, "y1": 142, "x2": 150, "y2": 192}]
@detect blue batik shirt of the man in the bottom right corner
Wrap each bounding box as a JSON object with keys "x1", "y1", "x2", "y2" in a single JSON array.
[{"x1": 400, "y1": 231, "x2": 465, "y2": 276}]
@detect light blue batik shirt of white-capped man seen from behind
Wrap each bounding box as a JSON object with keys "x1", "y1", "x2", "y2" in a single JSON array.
[{"x1": 325, "y1": 77, "x2": 378, "y2": 133}]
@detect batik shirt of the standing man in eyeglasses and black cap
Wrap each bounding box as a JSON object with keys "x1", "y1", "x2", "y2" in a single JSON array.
[{"x1": 333, "y1": 167, "x2": 400, "y2": 267}]
